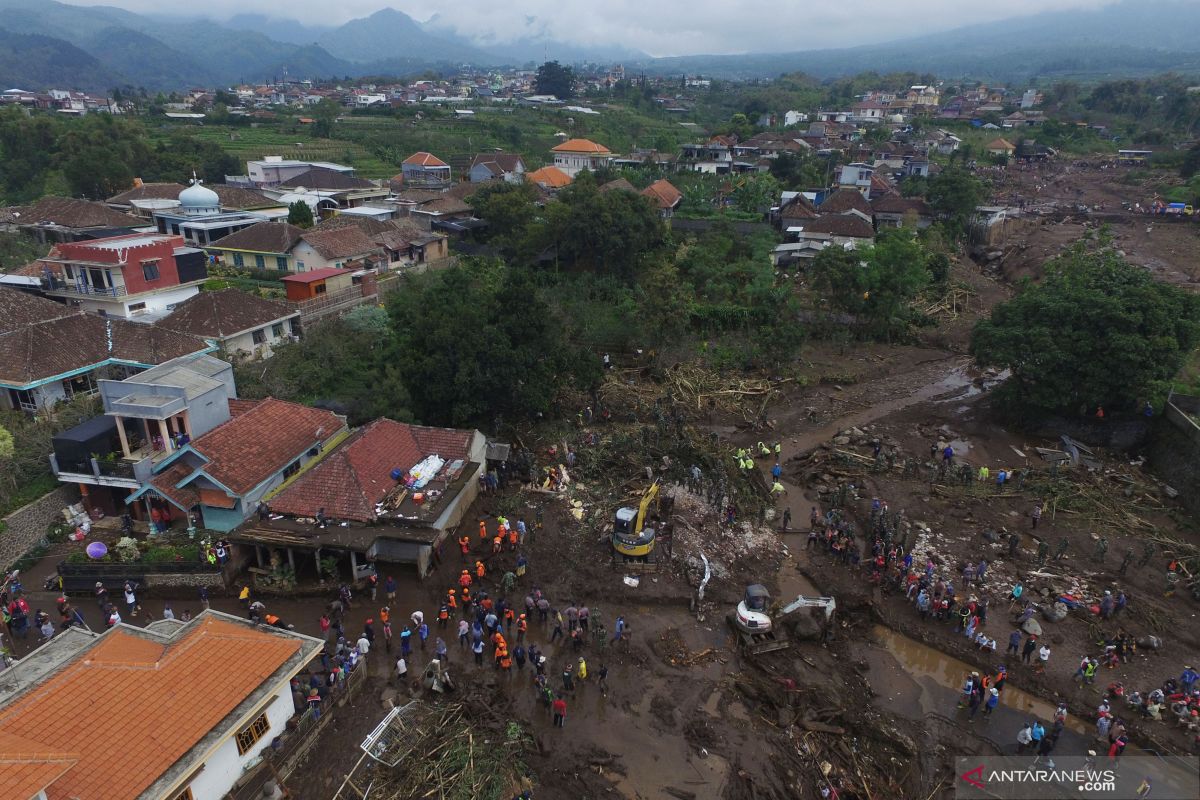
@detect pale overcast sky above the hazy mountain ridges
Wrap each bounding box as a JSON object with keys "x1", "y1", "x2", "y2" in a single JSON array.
[{"x1": 66, "y1": 0, "x2": 1115, "y2": 55}]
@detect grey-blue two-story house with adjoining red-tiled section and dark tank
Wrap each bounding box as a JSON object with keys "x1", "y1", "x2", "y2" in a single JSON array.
[{"x1": 50, "y1": 355, "x2": 347, "y2": 531}]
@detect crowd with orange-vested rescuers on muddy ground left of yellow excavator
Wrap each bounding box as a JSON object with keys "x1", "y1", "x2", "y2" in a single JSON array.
[{"x1": 288, "y1": 513, "x2": 631, "y2": 727}]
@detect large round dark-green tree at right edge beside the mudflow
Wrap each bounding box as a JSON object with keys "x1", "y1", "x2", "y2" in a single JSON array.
[{"x1": 971, "y1": 240, "x2": 1200, "y2": 413}]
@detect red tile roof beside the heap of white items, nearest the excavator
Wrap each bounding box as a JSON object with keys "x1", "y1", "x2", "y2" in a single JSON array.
[{"x1": 270, "y1": 419, "x2": 473, "y2": 522}]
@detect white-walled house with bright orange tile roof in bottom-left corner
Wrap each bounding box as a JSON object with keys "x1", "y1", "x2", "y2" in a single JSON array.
[{"x1": 0, "y1": 610, "x2": 324, "y2": 800}]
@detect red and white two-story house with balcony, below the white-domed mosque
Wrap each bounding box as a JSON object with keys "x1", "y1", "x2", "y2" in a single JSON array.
[{"x1": 38, "y1": 234, "x2": 209, "y2": 321}]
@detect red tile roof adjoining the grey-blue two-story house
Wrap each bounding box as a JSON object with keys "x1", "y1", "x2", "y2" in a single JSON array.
[{"x1": 192, "y1": 397, "x2": 346, "y2": 494}]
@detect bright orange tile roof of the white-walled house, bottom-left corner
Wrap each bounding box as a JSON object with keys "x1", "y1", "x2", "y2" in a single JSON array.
[{"x1": 0, "y1": 616, "x2": 301, "y2": 800}]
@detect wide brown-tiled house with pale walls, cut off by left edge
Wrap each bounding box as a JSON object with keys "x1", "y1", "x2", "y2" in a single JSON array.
[{"x1": 0, "y1": 288, "x2": 214, "y2": 413}]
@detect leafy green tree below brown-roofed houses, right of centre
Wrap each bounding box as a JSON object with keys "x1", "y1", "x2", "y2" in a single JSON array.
[{"x1": 810, "y1": 228, "x2": 930, "y2": 341}]
